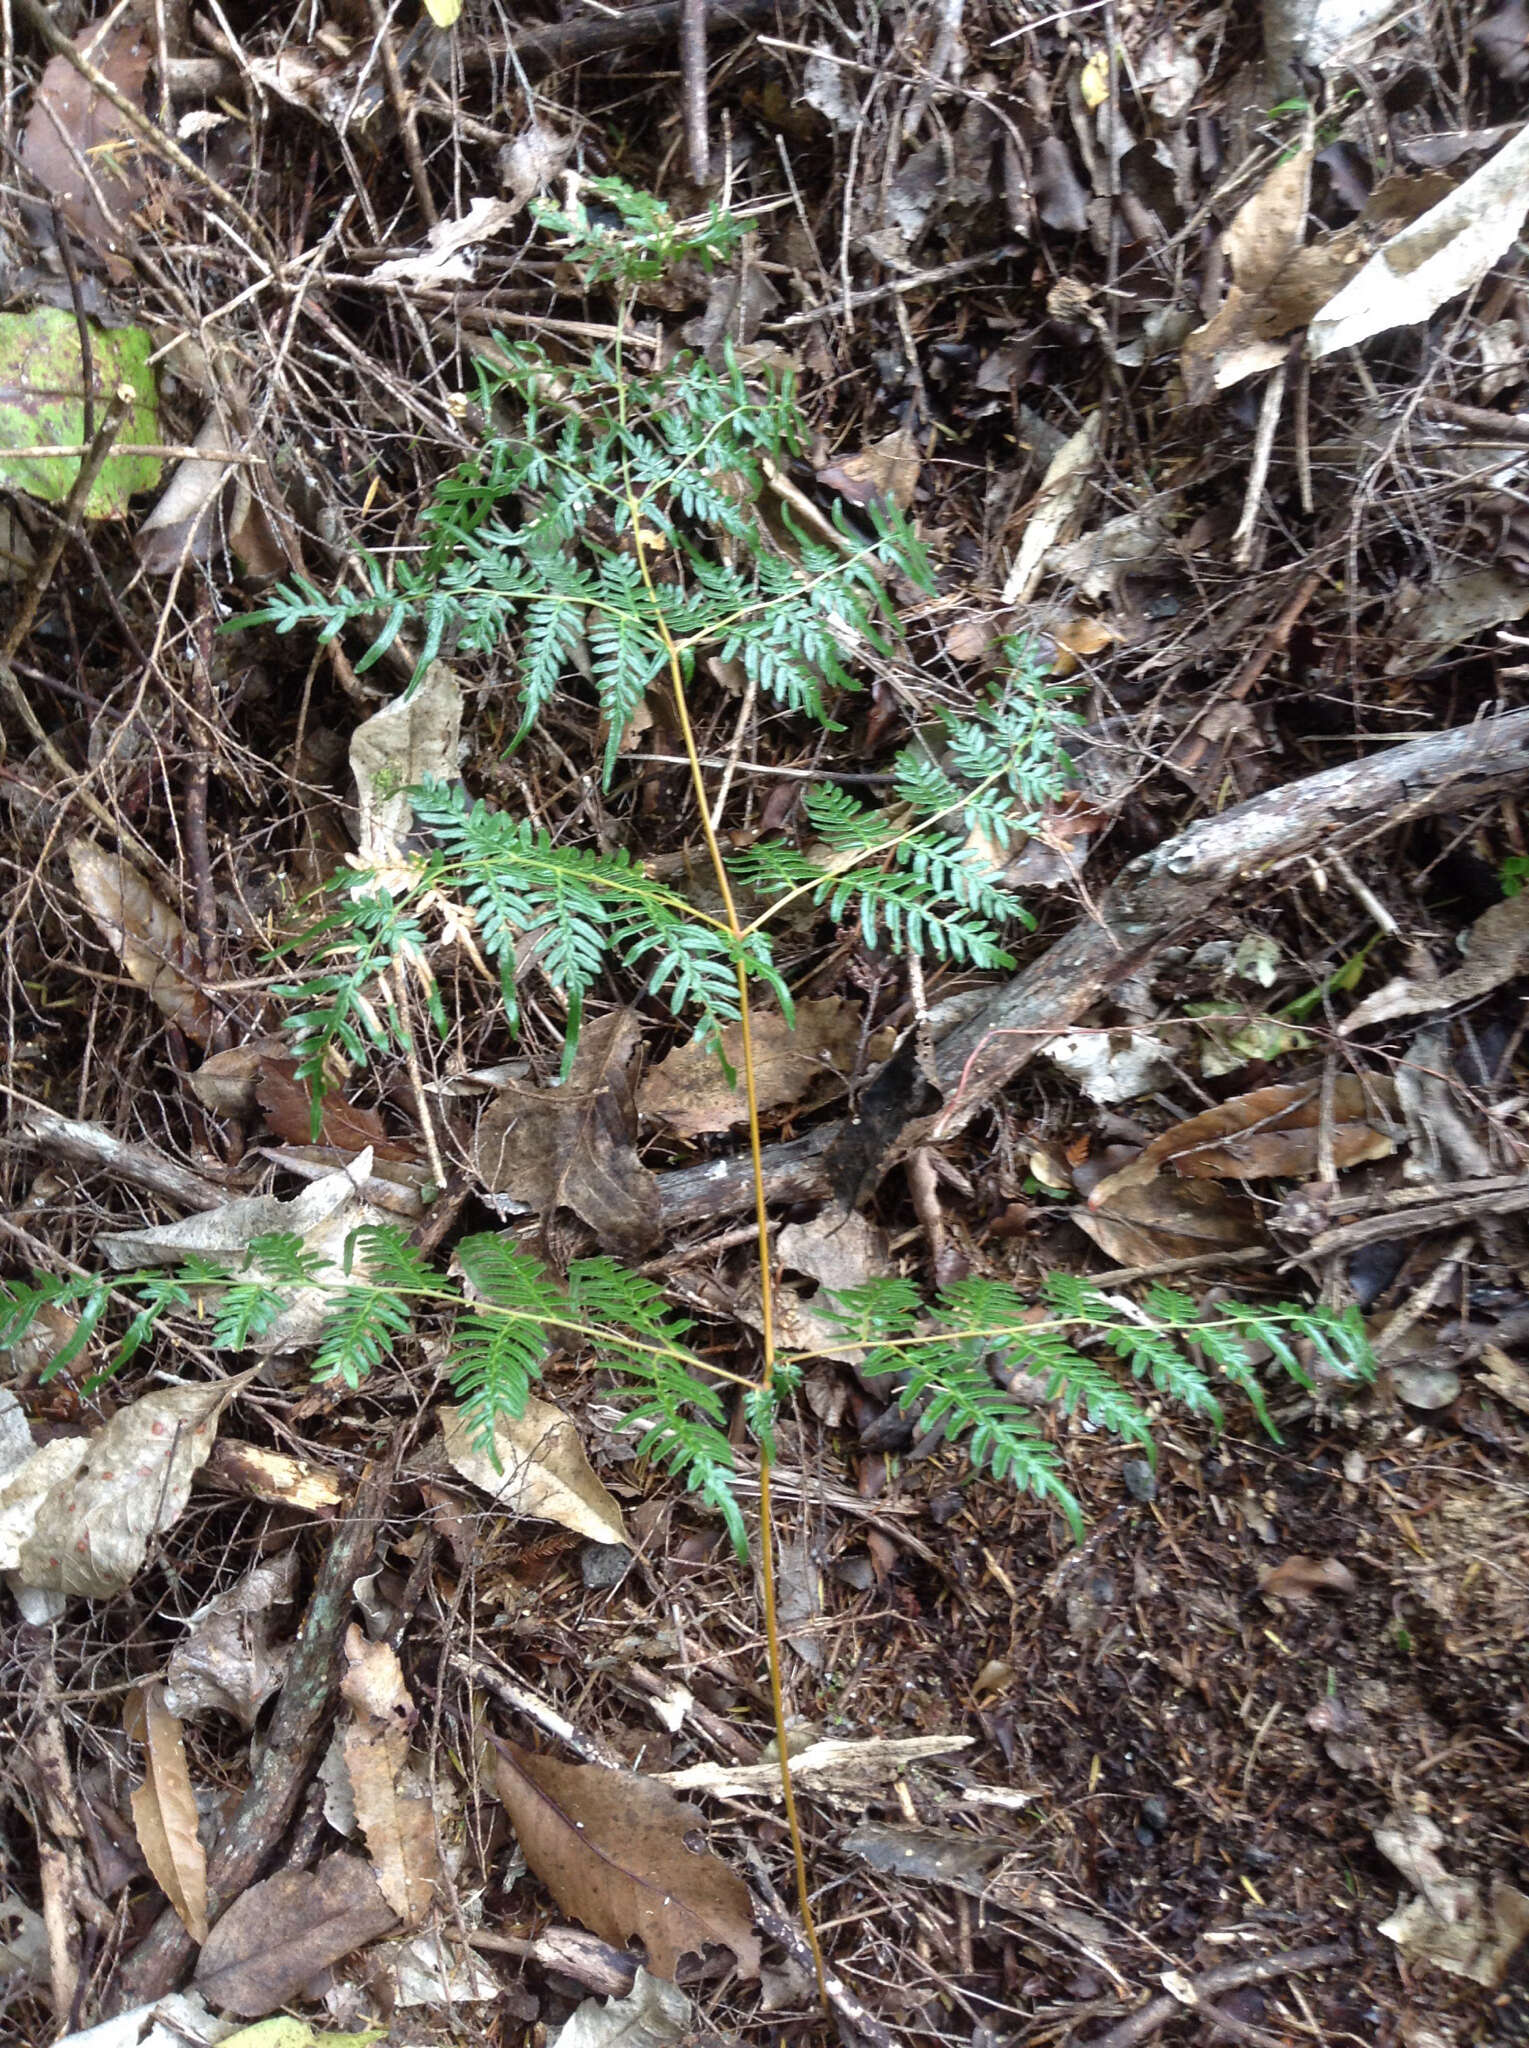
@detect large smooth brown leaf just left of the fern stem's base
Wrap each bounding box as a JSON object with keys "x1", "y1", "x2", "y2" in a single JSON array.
[{"x1": 493, "y1": 1741, "x2": 759, "y2": 1976}]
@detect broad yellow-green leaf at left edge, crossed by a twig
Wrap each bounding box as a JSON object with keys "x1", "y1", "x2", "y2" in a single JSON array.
[{"x1": 0, "y1": 305, "x2": 162, "y2": 518}]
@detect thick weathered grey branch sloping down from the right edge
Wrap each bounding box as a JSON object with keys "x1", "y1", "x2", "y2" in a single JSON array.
[{"x1": 925, "y1": 711, "x2": 1529, "y2": 1147}]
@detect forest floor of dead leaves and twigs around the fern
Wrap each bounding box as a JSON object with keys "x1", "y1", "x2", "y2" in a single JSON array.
[{"x1": 0, "y1": 0, "x2": 1529, "y2": 2048}]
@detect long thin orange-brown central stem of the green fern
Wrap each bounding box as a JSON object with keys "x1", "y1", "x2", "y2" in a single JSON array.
[{"x1": 616, "y1": 344, "x2": 829, "y2": 2011}]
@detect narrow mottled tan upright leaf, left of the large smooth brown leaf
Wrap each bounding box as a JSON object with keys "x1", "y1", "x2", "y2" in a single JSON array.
[{"x1": 340, "y1": 1622, "x2": 440, "y2": 1927}]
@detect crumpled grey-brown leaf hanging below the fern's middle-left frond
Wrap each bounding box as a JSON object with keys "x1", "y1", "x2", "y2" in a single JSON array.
[{"x1": 475, "y1": 1010, "x2": 661, "y2": 1257}]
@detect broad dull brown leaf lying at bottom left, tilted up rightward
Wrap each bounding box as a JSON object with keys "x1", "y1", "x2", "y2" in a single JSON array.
[{"x1": 194, "y1": 1855, "x2": 397, "y2": 2019}]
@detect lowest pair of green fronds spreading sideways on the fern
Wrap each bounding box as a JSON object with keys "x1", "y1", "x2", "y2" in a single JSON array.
[{"x1": 0, "y1": 1225, "x2": 1373, "y2": 1556}]
